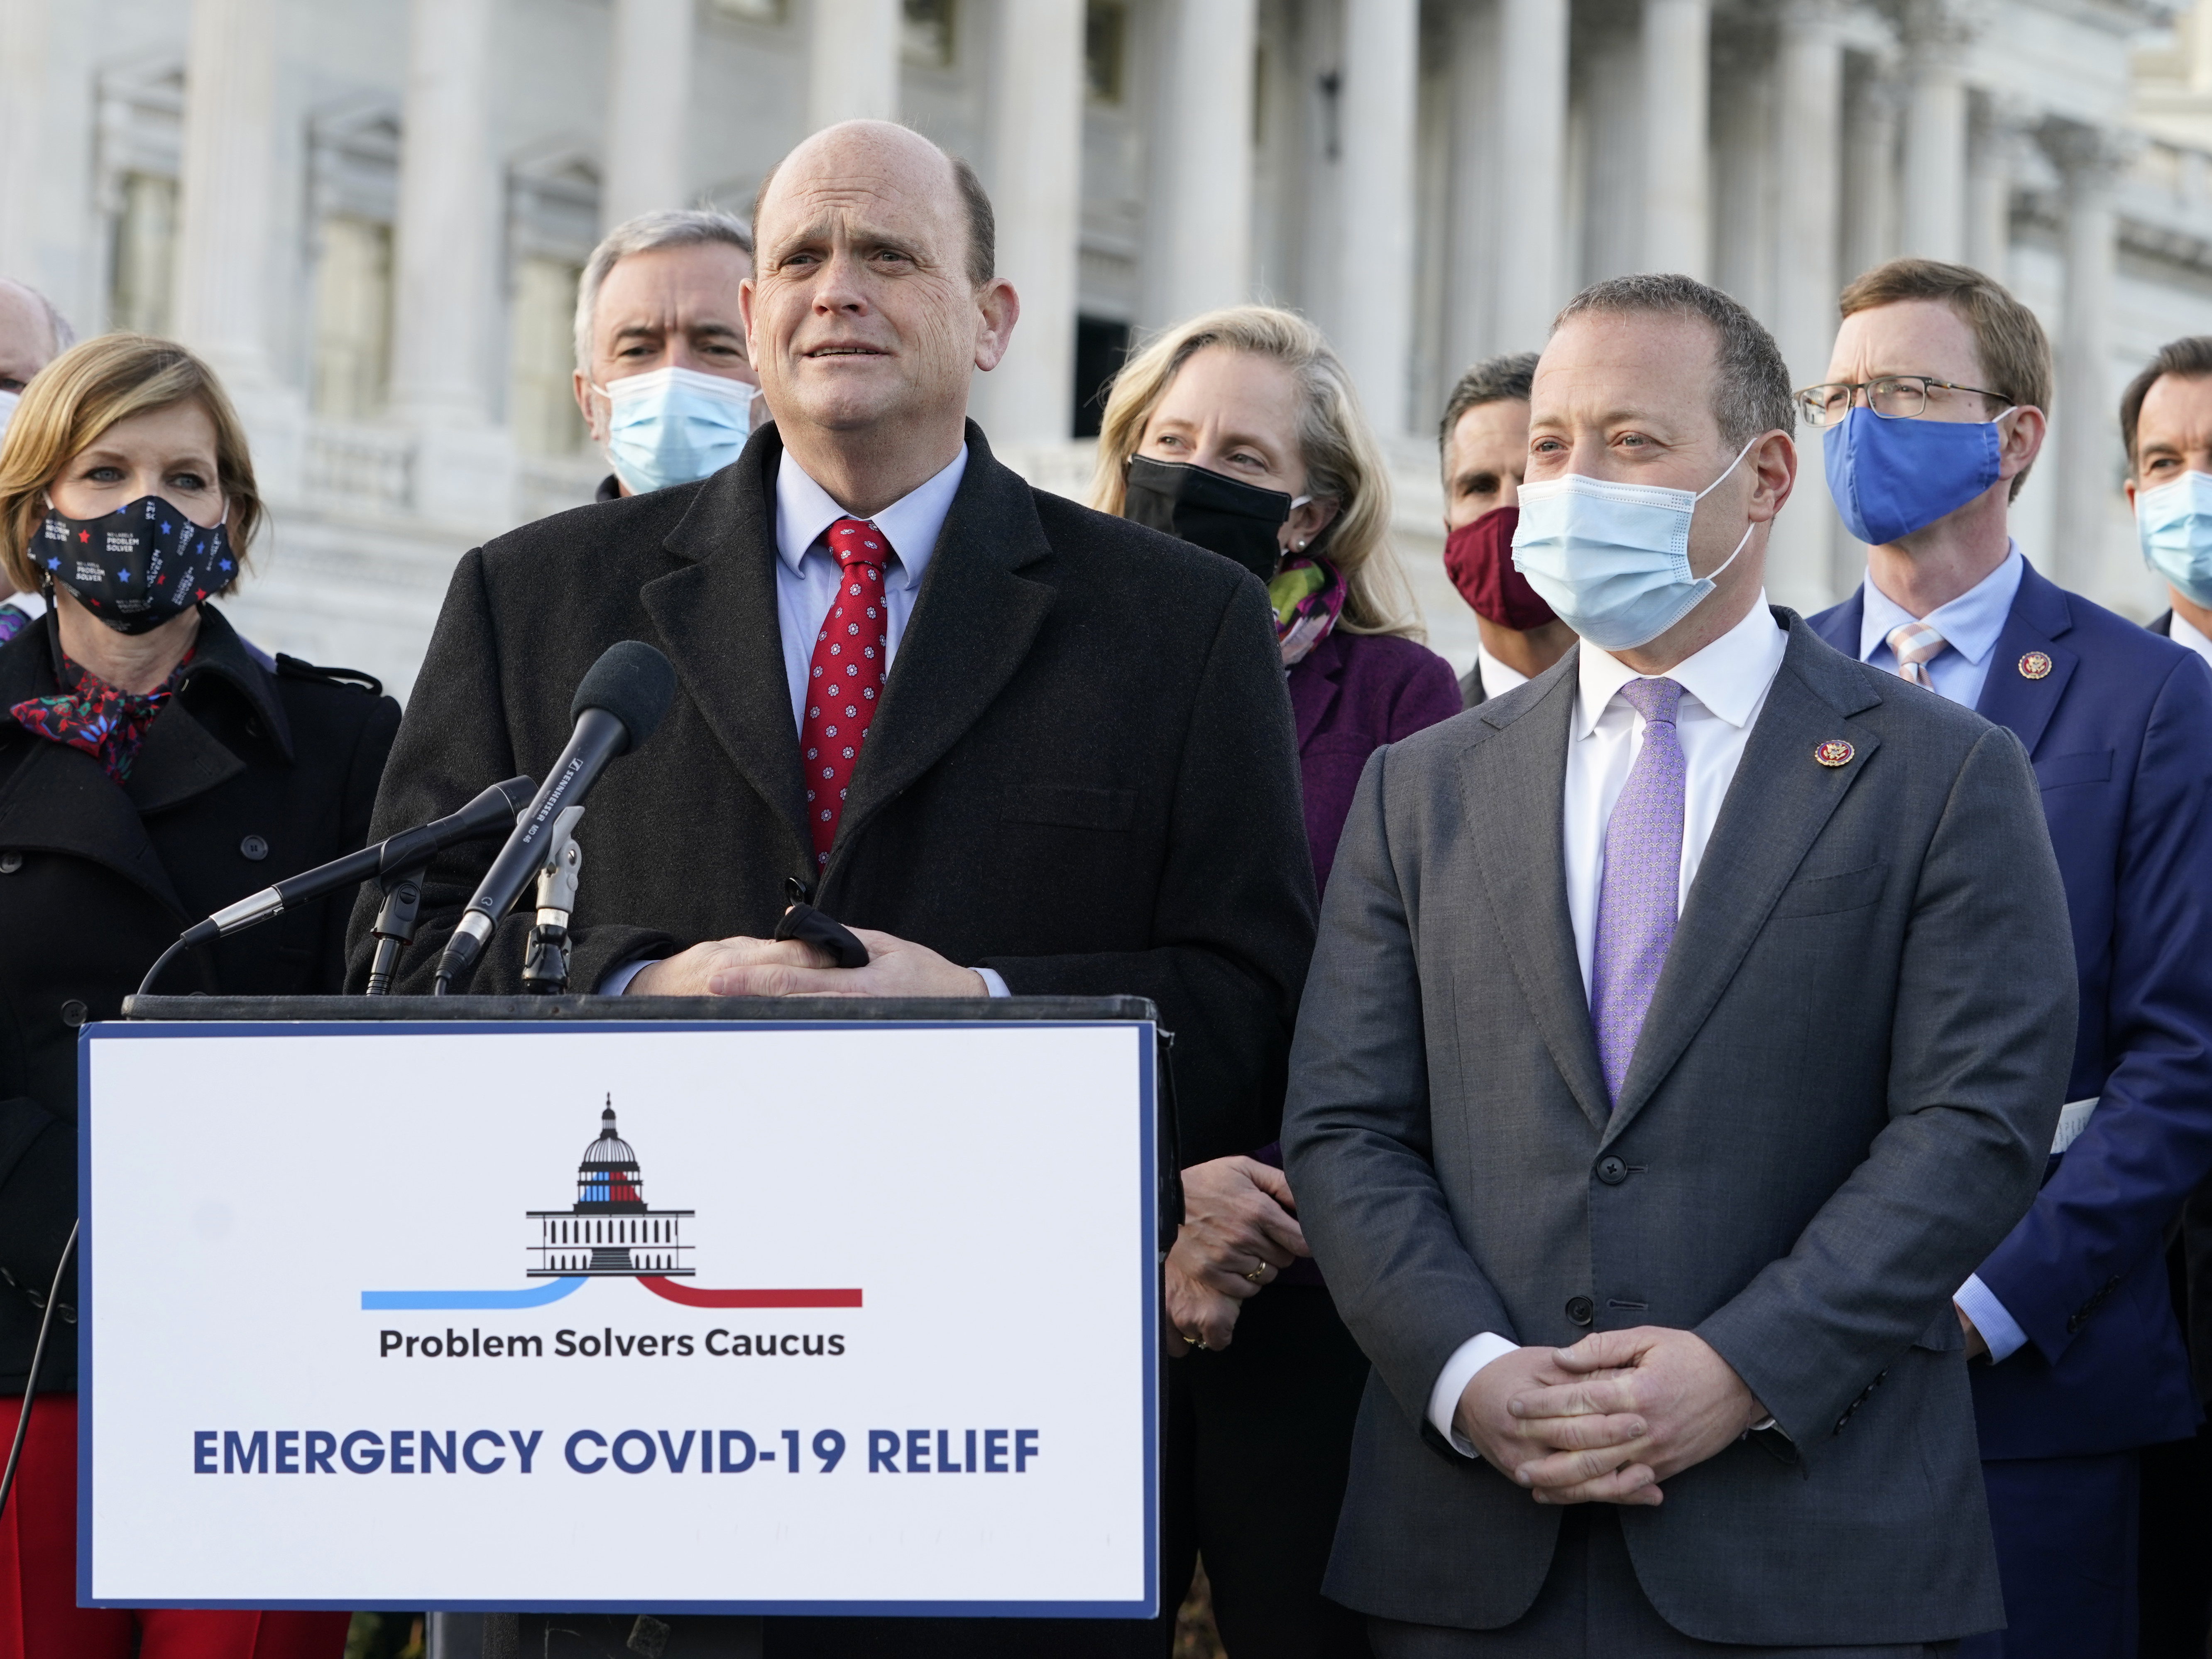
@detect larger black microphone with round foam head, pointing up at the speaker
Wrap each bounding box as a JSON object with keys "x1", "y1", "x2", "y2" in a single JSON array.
[{"x1": 438, "y1": 639, "x2": 677, "y2": 991}]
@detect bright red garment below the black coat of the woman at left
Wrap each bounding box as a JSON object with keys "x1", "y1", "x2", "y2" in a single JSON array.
[{"x1": 0, "y1": 1394, "x2": 352, "y2": 1659}]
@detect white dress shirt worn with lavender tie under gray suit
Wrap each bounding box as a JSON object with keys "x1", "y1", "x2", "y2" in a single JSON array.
[{"x1": 1429, "y1": 593, "x2": 1789, "y2": 1458}]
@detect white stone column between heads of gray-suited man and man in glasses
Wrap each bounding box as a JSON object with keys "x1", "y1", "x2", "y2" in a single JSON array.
[{"x1": 1767, "y1": 0, "x2": 1843, "y2": 613}]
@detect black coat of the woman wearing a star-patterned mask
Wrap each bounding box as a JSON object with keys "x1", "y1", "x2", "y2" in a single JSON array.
[{"x1": 0, "y1": 606, "x2": 400, "y2": 1394}]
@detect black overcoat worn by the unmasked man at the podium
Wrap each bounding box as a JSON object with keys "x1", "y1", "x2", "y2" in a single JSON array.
[{"x1": 352, "y1": 425, "x2": 1316, "y2": 1164}]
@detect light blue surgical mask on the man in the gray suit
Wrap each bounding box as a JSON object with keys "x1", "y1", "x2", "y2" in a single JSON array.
[{"x1": 1513, "y1": 438, "x2": 1759, "y2": 650}]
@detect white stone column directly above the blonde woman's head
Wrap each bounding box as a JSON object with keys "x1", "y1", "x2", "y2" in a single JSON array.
[{"x1": 1150, "y1": 0, "x2": 1259, "y2": 328}]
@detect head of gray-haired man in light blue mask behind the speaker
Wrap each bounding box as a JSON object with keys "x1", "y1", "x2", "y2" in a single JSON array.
[{"x1": 575, "y1": 208, "x2": 761, "y2": 502}]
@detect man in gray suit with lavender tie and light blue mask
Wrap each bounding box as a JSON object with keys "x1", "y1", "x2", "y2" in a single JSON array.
[{"x1": 1283, "y1": 276, "x2": 2075, "y2": 1659}]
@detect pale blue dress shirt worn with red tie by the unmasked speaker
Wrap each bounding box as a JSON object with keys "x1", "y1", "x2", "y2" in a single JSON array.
[{"x1": 599, "y1": 445, "x2": 1009, "y2": 998}]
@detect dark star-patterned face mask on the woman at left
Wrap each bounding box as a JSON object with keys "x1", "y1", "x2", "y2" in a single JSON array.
[{"x1": 31, "y1": 495, "x2": 239, "y2": 633}]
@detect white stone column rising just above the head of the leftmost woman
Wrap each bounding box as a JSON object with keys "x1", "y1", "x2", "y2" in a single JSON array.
[{"x1": 175, "y1": 0, "x2": 276, "y2": 396}]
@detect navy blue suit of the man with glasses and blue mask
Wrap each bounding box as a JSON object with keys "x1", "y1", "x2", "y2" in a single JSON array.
[{"x1": 1812, "y1": 566, "x2": 2212, "y2": 1652}]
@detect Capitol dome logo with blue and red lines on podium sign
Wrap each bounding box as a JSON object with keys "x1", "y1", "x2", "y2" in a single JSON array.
[{"x1": 360, "y1": 1095, "x2": 861, "y2": 1312}]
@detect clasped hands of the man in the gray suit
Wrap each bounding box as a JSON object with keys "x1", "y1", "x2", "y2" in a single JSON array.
[{"x1": 1451, "y1": 1325, "x2": 1767, "y2": 1504}]
